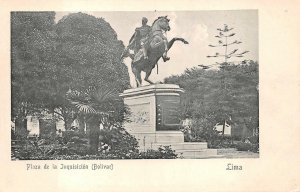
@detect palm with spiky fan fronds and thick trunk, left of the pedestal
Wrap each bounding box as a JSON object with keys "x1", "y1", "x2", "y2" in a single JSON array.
[{"x1": 67, "y1": 87, "x2": 126, "y2": 154}]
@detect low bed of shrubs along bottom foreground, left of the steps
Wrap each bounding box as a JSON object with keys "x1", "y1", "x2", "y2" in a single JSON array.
[{"x1": 12, "y1": 124, "x2": 177, "y2": 160}]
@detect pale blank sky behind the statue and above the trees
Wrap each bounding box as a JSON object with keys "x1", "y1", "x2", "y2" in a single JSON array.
[{"x1": 55, "y1": 10, "x2": 258, "y2": 86}]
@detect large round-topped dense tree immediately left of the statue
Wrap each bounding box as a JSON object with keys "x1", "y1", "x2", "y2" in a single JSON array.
[{"x1": 52, "y1": 13, "x2": 130, "y2": 127}]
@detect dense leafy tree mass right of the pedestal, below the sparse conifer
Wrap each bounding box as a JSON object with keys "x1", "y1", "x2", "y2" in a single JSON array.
[{"x1": 165, "y1": 61, "x2": 258, "y2": 140}]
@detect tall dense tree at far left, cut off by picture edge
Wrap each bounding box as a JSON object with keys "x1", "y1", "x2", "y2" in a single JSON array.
[{"x1": 11, "y1": 12, "x2": 56, "y2": 133}]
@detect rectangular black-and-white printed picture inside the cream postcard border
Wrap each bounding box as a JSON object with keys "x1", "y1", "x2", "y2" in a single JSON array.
[{"x1": 11, "y1": 10, "x2": 259, "y2": 160}]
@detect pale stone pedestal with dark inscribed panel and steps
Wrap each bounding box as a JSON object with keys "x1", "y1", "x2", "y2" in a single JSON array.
[{"x1": 120, "y1": 84, "x2": 216, "y2": 158}]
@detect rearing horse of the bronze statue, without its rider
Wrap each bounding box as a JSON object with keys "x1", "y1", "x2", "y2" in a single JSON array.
[{"x1": 121, "y1": 16, "x2": 188, "y2": 87}]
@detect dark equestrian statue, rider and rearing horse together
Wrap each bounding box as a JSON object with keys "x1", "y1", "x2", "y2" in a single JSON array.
[{"x1": 121, "y1": 16, "x2": 188, "y2": 87}]
